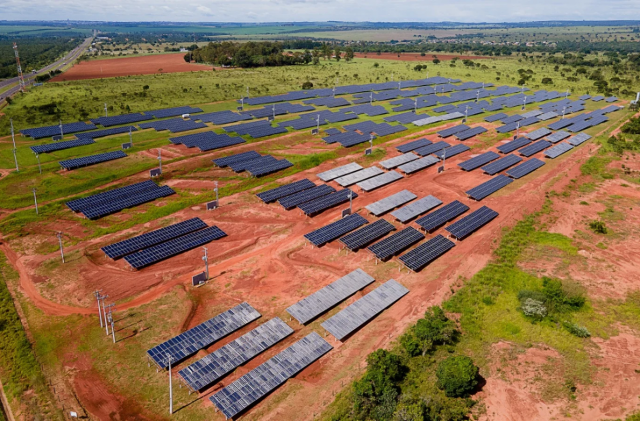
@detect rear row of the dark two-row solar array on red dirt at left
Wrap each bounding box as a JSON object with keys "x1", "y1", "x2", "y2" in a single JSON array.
[{"x1": 101, "y1": 218, "x2": 207, "y2": 260}]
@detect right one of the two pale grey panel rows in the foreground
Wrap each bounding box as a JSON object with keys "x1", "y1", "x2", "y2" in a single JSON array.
[{"x1": 321, "y1": 279, "x2": 409, "y2": 341}]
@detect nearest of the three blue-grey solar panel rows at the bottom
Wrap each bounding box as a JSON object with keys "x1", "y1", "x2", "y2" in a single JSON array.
[{"x1": 209, "y1": 332, "x2": 333, "y2": 419}]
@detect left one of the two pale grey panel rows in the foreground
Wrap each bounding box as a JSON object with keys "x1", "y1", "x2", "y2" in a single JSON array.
[{"x1": 287, "y1": 268, "x2": 376, "y2": 324}]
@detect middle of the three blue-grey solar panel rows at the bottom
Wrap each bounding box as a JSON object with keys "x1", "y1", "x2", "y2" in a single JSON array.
[{"x1": 178, "y1": 317, "x2": 293, "y2": 391}]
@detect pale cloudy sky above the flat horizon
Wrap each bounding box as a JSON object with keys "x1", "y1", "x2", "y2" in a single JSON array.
[{"x1": 0, "y1": 0, "x2": 640, "y2": 22}]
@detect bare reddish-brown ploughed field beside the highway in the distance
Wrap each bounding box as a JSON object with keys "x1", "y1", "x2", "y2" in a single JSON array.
[{"x1": 51, "y1": 54, "x2": 213, "y2": 82}]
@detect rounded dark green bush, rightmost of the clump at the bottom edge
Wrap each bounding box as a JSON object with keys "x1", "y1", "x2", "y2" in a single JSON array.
[{"x1": 436, "y1": 355, "x2": 478, "y2": 398}]
